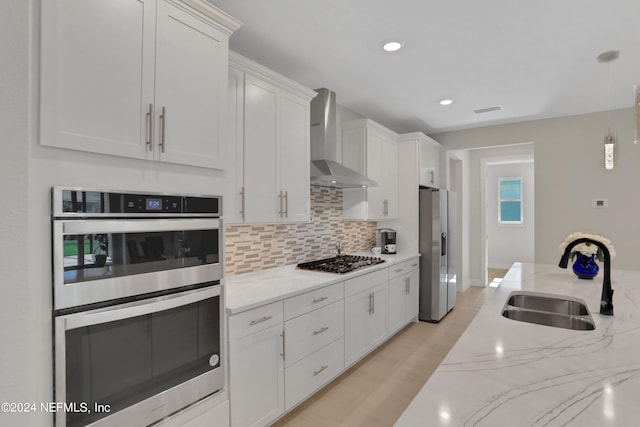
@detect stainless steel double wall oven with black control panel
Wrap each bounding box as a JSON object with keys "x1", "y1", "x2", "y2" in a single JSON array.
[{"x1": 52, "y1": 187, "x2": 225, "y2": 426}]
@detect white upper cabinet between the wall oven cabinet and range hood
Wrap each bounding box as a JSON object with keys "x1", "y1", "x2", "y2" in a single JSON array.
[{"x1": 225, "y1": 52, "x2": 316, "y2": 224}]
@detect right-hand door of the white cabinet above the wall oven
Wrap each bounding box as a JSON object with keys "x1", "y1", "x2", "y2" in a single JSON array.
[{"x1": 155, "y1": 0, "x2": 229, "y2": 169}]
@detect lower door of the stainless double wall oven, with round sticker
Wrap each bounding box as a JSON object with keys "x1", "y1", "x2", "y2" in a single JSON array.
[{"x1": 55, "y1": 284, "x2": 224, "y2": 426}]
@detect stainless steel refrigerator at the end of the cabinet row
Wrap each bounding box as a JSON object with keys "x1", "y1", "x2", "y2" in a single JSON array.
[{"x1": 418, "y1": 187, "x2": 456, "y2": 322}]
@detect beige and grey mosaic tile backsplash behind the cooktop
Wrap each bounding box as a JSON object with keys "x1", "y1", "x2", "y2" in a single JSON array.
[{"x1": 225, "y1": 187, "x2": 377, "y2": 276}]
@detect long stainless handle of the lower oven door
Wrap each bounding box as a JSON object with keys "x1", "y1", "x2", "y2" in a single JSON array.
[{"x1": 61, "y1": 285, "x2": 220, "y2": 330}]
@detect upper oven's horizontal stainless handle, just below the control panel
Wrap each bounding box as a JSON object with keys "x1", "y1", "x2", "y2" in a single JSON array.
[{"x1": 62, "y1": 218, "x2": 220, "y2": 235}]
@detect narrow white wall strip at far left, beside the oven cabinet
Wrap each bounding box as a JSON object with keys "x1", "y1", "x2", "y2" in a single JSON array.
[{"x1": 0, "y1": 1, "x2": 31, "y2": 426}]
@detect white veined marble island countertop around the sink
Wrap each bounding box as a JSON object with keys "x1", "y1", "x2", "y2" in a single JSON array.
[{"x1": 396, "y1": 263, "x2": 640, "y2": 427}]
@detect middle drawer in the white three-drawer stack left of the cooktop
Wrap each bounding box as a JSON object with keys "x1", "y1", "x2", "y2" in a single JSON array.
[{"x1": 284, "y1": 300, "x2": 344, "y2": 366}]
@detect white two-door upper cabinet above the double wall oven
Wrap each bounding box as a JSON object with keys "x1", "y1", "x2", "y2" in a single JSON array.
[{"x1": 40, "y1": 0, "x2": 240, "y2": 169}]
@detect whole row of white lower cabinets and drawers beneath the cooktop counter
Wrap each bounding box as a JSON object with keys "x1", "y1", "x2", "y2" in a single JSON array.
[{"x1": 228, "y1": 258, "x2": 419, "y2": 427}]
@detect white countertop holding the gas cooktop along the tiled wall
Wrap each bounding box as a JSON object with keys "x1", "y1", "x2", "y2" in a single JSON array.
[{"x1": 225, "y1": 253, "x2": 420, "y2": 314}]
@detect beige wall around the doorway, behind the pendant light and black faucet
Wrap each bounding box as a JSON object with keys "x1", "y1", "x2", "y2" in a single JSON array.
[{"x1": 431, "y1": 109, "x2": 640, "y2": 277}]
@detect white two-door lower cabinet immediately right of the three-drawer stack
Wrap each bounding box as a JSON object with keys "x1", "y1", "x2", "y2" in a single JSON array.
[{"x1": 344, "y1": 269, "x2": 388, "y2": 367}]
